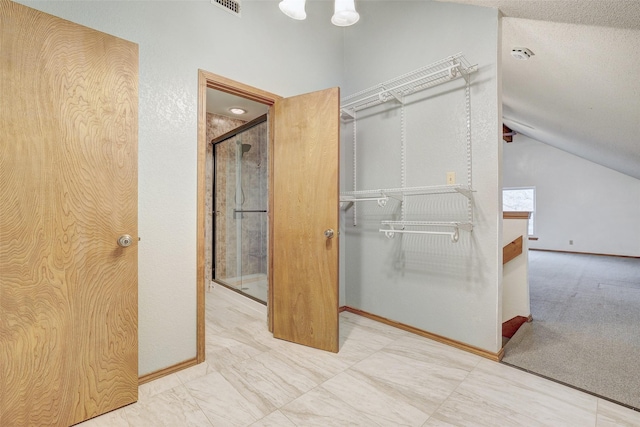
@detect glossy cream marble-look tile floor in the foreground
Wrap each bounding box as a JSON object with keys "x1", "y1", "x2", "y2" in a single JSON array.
[{"x1": 80, "y1": 286, "x2": 640, "y2": 427}]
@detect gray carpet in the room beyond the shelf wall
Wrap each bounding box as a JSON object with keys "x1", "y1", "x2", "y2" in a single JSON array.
[{"x1": 503, "y1": 250, "x2": 640, "y2": 409}]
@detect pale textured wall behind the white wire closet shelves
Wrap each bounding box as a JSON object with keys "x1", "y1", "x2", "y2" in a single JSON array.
[{"x1": 341, "y1": 1, "x2": 502, "y2": 352}]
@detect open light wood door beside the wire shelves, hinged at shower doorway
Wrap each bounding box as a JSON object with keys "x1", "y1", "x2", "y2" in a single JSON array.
[{"x1": 271, "y1": 88, "x2": 340, "y2": 352}]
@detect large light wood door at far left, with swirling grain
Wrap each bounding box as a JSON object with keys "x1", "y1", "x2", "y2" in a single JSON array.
[{"x1": 0, "y1": 0, "x2": 138, "y2": 426}]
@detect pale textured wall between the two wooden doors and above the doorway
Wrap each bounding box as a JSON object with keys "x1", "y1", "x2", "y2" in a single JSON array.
[{"x1": 22, "y1": 0, "x2": 343, "y2": 375}]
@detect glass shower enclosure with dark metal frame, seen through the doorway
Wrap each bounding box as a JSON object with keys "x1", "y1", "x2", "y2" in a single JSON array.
[{"x1": 212, "y1": 116, "x2": 268, "y2": 304}]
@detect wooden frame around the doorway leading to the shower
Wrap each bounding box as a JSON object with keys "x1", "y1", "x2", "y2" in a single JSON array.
[{"x1": 196, "y1": 70, "x2": 282, "y2": 363}]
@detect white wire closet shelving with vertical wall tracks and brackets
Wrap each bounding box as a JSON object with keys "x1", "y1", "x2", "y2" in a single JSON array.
[{"x1": 340, "y1": 53, "x2": 478, "y2": 242}]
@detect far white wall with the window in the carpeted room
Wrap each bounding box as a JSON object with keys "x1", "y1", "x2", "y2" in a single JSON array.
[{"x1": 504, "y1": 135, "x2": 640, "y2": 256}]
